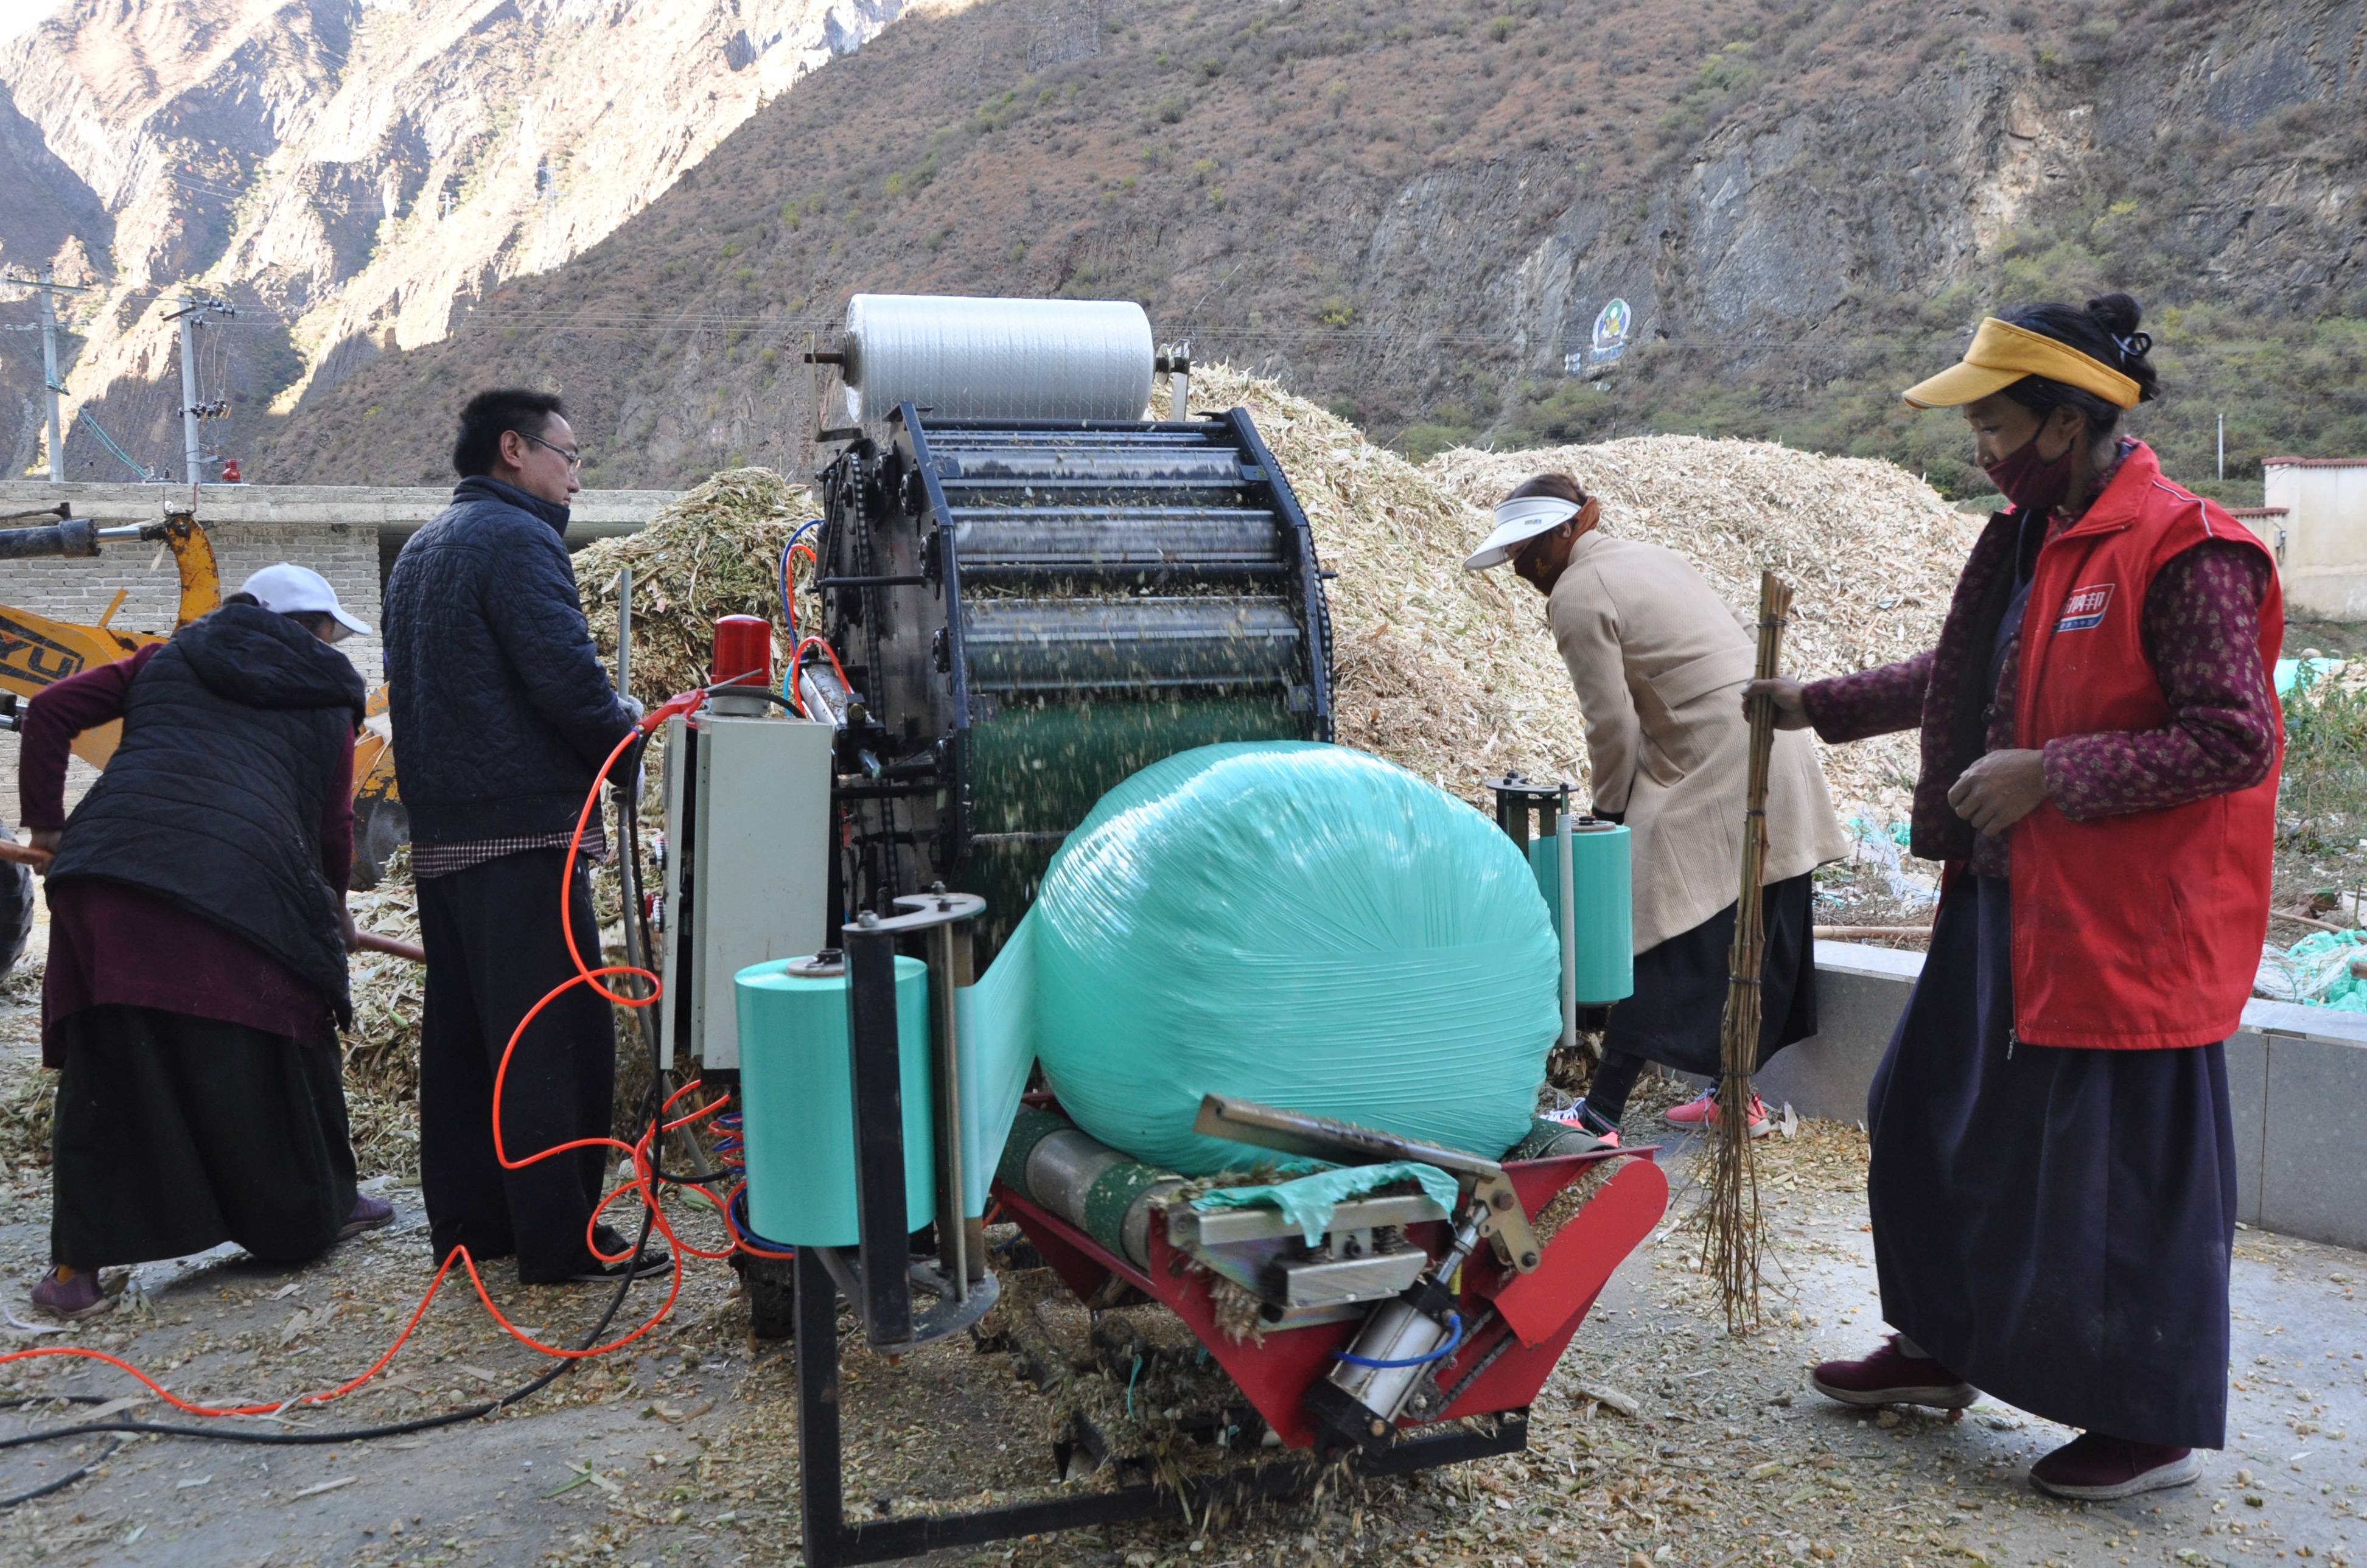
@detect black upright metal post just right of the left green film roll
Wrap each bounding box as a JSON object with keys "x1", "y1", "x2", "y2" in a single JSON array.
[{"x1": 833, "y1": 927, "x2": 911, "y2": 1346}]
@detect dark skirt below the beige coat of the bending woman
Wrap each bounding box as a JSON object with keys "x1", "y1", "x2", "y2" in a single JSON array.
[{"x1": 1603, "y1": 873, "x2": 1816, "y2": 1076}]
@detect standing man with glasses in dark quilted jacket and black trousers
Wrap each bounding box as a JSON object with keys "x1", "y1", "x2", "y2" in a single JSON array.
[{"x1": 386, "y1": 390, "x2": 668, "y2": 1284}]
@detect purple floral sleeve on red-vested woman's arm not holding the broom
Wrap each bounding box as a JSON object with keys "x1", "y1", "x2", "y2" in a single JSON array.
[{"x1": 2045, "y1": 542, "x2": 2282, "y2": 821}]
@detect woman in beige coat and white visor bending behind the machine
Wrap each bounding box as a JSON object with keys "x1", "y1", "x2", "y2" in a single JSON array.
[{"x1": 1465, "y1": 473, "x2": 1848, "y2": 1140}]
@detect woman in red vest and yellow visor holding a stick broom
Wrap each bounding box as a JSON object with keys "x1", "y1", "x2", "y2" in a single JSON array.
[{"x1": 1752, "y1": 293, "x2": 2284, "y2": 1499}]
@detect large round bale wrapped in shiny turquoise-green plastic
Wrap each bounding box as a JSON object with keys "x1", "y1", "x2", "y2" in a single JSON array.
[{"x1": 1027, "y1": 742, "x2": 1560, "y2": 1176}]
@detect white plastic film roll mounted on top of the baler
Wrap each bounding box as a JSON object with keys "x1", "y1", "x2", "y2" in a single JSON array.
[{"x1": 845, "y1": 293, "x2": 1153, "y2": 421}]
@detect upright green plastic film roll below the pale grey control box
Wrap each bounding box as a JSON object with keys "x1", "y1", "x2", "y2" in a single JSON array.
[{"x1": 734, "y1": 958, "x2": 932, "y2": 1246}]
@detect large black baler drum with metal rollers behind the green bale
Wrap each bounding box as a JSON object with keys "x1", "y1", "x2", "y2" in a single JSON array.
[{"x1": 812, "y1": 331, "x2": 1333, "y2": 960}]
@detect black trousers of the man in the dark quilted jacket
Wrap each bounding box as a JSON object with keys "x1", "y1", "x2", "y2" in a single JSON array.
[{"x1": 419, "y1": 849, "x2": 615, "y2": 1282}]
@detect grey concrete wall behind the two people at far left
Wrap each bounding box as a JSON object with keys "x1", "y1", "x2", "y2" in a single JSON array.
[{"x1": 0, "y1": 480, "x2": 679, "y2": 823}]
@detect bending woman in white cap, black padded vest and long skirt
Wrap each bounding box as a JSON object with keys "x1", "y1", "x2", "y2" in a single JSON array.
[{"x1": 19, "y1": 563, "x2": 393, "y2": 1317}]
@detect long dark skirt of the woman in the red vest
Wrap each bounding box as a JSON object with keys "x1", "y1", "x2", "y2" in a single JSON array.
[{"x1": 1865, "y1": 877, "x2": 2234, "y2": 1448}]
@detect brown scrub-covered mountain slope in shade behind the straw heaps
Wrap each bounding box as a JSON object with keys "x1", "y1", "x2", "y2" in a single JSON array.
[{"x1": 18, "y1": 0, "x2": 2367, "y2": 497}]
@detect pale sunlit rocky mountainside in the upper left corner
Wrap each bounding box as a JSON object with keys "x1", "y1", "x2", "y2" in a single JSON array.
[{"x1": 0, "y1": 0, "x2": 904, "y2": 478}]
